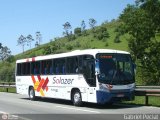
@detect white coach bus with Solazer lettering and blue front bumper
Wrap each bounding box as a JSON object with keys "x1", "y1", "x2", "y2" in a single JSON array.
[{"x1": 16, "y1": 49, "x2": 135, "y2": 106}]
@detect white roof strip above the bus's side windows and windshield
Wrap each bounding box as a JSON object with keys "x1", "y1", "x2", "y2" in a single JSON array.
[{"x1": 16, "y1": 49, "x2": 130, "y2": 63}]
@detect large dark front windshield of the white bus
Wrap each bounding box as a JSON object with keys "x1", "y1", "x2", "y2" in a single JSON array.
[{"x1": 96, "y1": 53, "x2": 135, "y2": 85}]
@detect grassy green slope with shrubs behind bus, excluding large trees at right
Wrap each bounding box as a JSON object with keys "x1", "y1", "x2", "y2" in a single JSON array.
[{"x1": 0, "y1": 20, "x2": 129, "y2": 81}]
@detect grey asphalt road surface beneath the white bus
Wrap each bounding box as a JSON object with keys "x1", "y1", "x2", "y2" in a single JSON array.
[{"x1": 0, "y1": 92, "x2": 160, "y2": 120}]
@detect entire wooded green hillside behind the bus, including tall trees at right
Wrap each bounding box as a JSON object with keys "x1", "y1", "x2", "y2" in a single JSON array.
[{"x1": 0, "y1": 0, "x2": 160, "y2": 85}]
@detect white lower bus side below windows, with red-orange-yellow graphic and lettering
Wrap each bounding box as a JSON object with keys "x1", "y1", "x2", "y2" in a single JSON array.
[{"x1": 16, "y1": 75, "x2": 96, "y2": 103}]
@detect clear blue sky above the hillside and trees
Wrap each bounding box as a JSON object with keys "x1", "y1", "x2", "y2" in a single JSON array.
[{"x1": 0, "y1": 0, "x2": 135, "y2": 55}]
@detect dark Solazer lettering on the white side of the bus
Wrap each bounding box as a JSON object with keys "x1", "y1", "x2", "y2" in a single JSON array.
[{"x1": 53, "y1": 77, "x2": 74, "y2": 84}]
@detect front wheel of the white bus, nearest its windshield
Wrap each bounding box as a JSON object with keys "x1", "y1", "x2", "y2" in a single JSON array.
[{"x1": 72, "y1": 90, "x2": 82, "y2": 106}]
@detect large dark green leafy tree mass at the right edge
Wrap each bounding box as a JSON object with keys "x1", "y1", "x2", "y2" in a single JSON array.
[{"x1": 120, "y1": 0, "x2": 160, "y2": 85}]
